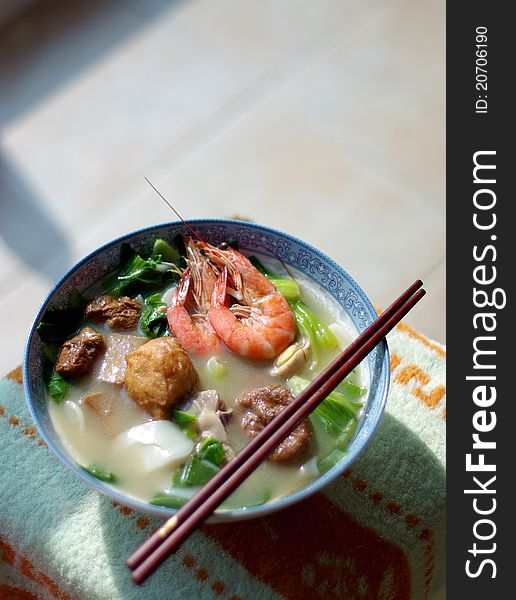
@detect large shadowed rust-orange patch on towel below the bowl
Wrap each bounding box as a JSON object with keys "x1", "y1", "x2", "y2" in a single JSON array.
[{"x1": 203, "y1": 494, "x2": 411, "y2": 600}]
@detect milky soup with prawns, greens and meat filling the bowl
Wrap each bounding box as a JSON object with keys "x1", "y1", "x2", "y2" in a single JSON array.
[{"x1": 42, "y1": 238, "x2": 369, "y2": 510}]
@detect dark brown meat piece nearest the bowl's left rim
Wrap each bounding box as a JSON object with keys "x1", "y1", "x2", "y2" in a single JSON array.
[{"x1": 55, "y1": 327, "x2": 105, "y2": 377}]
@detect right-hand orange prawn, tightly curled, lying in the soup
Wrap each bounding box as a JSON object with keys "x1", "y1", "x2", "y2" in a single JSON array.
[{"x1": 202, "y1": 243, "x2": 296, "y2": 359}]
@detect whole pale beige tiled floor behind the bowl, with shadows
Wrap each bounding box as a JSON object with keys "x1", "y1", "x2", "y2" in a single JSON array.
[{"x1": 0, "y1": 0, "x2": 445, "y2": 380}]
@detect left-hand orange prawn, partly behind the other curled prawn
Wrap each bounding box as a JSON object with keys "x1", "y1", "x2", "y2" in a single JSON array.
[{"x1": 167, "y1": 238, "x2": 222, "y2": 356}]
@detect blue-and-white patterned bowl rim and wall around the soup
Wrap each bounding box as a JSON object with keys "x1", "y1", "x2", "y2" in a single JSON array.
[{"x1": 24, "y1": 219, "x2": 389, "y2": 521}]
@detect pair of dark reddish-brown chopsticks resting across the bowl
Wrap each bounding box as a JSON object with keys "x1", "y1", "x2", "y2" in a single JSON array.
[{"x1": 126, "y1": 280, "x2": 426, "y2": 584}]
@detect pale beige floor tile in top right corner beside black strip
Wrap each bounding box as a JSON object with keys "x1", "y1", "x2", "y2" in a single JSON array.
[{"x1": 276, "y1": 0, "x2": 445, "y2": 214}]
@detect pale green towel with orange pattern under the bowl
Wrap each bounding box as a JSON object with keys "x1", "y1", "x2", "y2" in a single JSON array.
[{"x1": 0, "y1": 324, "x2": 446, "y2": 600}]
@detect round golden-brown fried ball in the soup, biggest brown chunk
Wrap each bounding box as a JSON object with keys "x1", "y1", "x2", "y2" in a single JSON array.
[{"x1": 125, "y1": 337, "x2": 199, "y2": 419}]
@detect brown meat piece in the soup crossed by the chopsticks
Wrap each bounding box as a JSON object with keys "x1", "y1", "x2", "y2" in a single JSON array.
[{"x1": 236, "y1": 385, "x2": 312, "y2": 463}]
